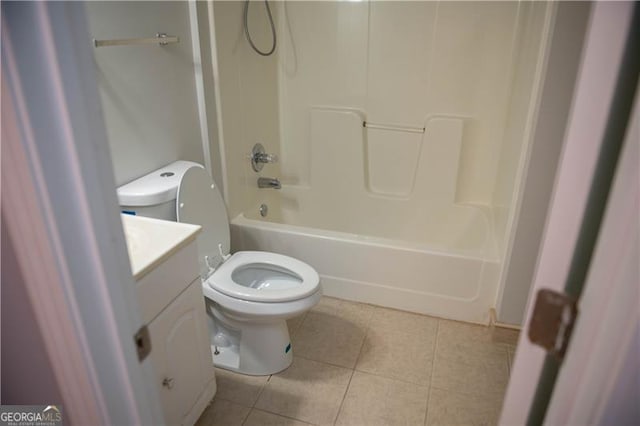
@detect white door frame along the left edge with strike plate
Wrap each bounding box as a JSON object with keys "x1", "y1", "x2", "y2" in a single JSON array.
[{"x1": 1, "y1": 2, "x2": 164, "y2": 424}]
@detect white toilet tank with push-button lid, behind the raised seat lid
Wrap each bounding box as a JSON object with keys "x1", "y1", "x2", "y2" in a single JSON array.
[{"x1": 118, "y1": 160, "x2": 204, "y2": 222}]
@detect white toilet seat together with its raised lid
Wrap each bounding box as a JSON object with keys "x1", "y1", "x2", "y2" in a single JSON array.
[{"x1": 176, "y1": 167, "x2": 320, "y2": 303}]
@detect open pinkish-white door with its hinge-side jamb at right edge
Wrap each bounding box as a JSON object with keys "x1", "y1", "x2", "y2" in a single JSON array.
[{"x1": 500, "y1": 3, "x2": 640, "y2": 424}]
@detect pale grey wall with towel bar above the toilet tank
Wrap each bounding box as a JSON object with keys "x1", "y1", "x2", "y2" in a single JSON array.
[{"x1": 86, "y1": 1, "x2": 204, "y2": 185}]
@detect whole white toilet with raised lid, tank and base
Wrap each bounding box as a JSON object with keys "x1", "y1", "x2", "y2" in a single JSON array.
[{"x1": 118, "y1": 161, "x2": 322, "y2": 375}]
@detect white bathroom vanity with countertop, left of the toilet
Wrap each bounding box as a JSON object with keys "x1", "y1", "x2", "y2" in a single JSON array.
[{"x1": 123, "y1": 217, "x2": 216, "y2": 425}]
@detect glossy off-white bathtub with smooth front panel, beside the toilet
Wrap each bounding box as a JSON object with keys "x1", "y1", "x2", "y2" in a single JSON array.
[{"x1": 231, "y1": 214, "x2": 499, "y2": 323}]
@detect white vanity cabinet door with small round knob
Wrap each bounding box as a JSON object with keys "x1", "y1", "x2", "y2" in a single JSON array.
[{"x1": 148, "y1": 278, "x2": 215, "y2": 425}]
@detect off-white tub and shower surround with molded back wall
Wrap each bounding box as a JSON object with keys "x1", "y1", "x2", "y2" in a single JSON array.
[{"x1": 214, "y1": 2, "x2": 553, "y2": 322}]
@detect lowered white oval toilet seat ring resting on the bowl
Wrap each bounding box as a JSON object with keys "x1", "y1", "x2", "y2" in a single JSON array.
[{"x1": 205, "y1": 251, "x2": 320, "y2": 302}]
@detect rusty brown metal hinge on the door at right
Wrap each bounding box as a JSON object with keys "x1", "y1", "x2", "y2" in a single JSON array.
[{"x1": 528, "y1": 289, "x2": 578, "y2": 361}]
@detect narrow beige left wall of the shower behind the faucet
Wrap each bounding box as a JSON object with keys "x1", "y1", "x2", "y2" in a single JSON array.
[{"x1": 213, "y1": 1, "x2": 282, "y2": 217}]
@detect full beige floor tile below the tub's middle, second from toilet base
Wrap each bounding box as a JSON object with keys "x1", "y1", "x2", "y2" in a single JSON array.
[{"x1": 356, "y1": 308, "x2": 438, "y2": 385}]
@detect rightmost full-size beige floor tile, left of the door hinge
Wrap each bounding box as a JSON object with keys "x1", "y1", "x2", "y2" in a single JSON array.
[{"x1": 431, "y1": 340, "x2": 509, "y2": 396}]
